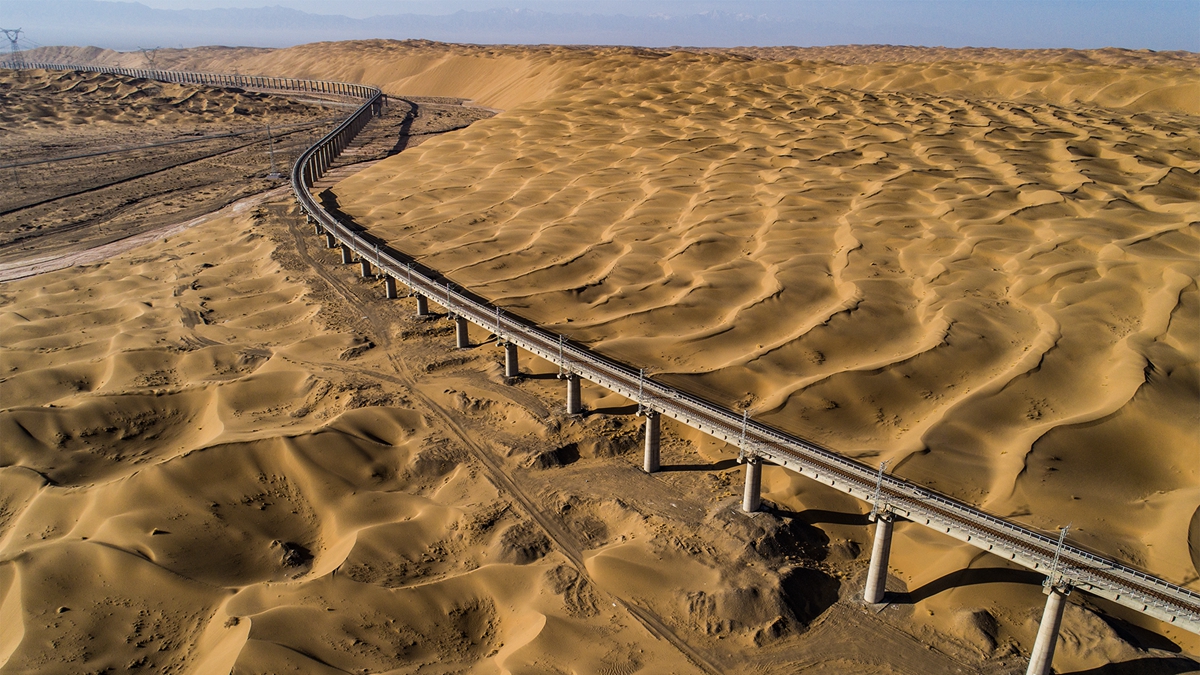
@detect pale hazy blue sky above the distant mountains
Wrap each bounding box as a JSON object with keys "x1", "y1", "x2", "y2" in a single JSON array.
[{"x1": 129, "y1": 0, "x2": 1200, "y2": 50}]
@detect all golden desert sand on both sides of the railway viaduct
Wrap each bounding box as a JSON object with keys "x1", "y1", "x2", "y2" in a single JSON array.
[{"x1": 0, "y1": 42, "x2": 1200, "y2": 673}]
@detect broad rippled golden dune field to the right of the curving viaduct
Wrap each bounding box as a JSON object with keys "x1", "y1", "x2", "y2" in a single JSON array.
[{"x1": 335, "y1": 52, "x2": 1200, "y2": 593}]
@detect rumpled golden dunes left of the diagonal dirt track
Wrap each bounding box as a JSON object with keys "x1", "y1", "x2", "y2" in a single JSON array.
[{"x1": 0, "y1": 207, "x2": 710, "y2": 673}]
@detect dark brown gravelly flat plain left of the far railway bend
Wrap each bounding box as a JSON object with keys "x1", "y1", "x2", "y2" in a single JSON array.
[{"x1": 0, "y1": 70, "x2": 342, "y2": 263}]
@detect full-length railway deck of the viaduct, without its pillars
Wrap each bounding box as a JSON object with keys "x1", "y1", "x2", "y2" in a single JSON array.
[{"x1": 14, "y1": 64, "x2": 1200, "y2": 633}]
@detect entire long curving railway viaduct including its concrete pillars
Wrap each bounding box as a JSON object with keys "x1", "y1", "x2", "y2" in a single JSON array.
[{"x1": 11, "y1": 64, "x2": 1200, "y2": 675}]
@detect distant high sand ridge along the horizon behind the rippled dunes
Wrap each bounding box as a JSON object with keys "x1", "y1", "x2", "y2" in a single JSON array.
[{"x1": 29, "y1": 40, "x2": 1200, "y2": 115}]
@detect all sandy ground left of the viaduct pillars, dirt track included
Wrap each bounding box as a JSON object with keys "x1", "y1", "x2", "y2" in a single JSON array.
[{"x1": 0, "y1": 202, "x2": 1080, "y2": 675}]
